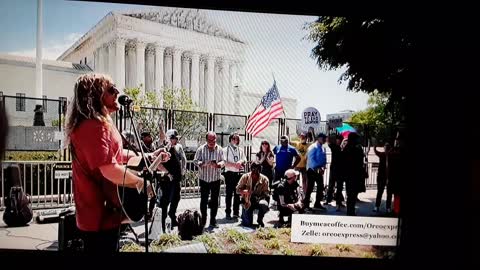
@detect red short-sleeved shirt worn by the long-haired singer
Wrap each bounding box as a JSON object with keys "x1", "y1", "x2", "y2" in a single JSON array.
[{"x1": 71, "y1": 119, "x2": 125, "y2": 231}]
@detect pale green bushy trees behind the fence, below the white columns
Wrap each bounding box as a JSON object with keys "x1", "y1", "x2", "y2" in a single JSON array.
[{"x1": 125, "y1": 87, "x2": 207, "y2": 146}]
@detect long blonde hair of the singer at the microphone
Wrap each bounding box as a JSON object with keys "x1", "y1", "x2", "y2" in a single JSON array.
[{"x1": 65, "y1": 73, "x2": 113, "y2": 146}]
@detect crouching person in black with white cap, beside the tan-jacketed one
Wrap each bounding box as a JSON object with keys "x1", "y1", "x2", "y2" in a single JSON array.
[{"x1": 275, "y1": 169, "x2": 304, "y2": 225}]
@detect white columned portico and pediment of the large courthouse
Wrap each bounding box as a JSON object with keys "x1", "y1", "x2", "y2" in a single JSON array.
[{"x1": 57, "y1": 7, "x2": 246, "y2": 113}]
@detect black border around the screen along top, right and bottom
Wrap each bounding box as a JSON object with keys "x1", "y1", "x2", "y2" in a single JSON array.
[{"x1": 0, "y1": 0, "x2": 472, "y2": 269}]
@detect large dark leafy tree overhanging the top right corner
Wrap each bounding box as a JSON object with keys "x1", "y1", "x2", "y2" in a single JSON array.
[{"x1": 305, "y1": 16, "x2": 415, "y2": 118}]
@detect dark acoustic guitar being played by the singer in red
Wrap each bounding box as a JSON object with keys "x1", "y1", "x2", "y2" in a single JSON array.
[{"x1": 113, "y1": 153, "x2": 168, "y2": 223}]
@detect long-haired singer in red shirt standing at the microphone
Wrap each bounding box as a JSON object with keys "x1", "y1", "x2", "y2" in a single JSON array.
[{"x1": 66, "y1": 74, "x2": 157, "y2": 253}]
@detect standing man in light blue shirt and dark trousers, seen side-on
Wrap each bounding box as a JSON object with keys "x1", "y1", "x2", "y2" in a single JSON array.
[{"x1": 304, "y1": 133, "x2": 327, "y2": 210}]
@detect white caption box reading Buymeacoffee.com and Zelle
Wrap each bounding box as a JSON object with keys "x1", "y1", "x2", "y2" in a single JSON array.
[{"x1": 291, "y1": 214, "x2": 398, "y2": 246}]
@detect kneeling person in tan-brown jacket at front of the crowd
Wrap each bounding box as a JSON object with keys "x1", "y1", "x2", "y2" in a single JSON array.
[{"x1": 237, "y1": 162, "x2": 270, "y2": 227}]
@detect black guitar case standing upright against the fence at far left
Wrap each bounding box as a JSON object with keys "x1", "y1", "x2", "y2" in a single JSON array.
[{"x1": 3, "y1": 165, "x2": 33, "y2": 227}]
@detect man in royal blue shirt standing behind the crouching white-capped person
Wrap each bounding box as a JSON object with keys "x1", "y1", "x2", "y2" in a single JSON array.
[{"x1": 273, "y1": 135, "x2": 301, "y2": 186}]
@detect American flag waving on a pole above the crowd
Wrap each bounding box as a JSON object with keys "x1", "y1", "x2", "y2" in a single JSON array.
[{"x1": 246, "y1": 82, "x2": 283, "y2": 137}]
